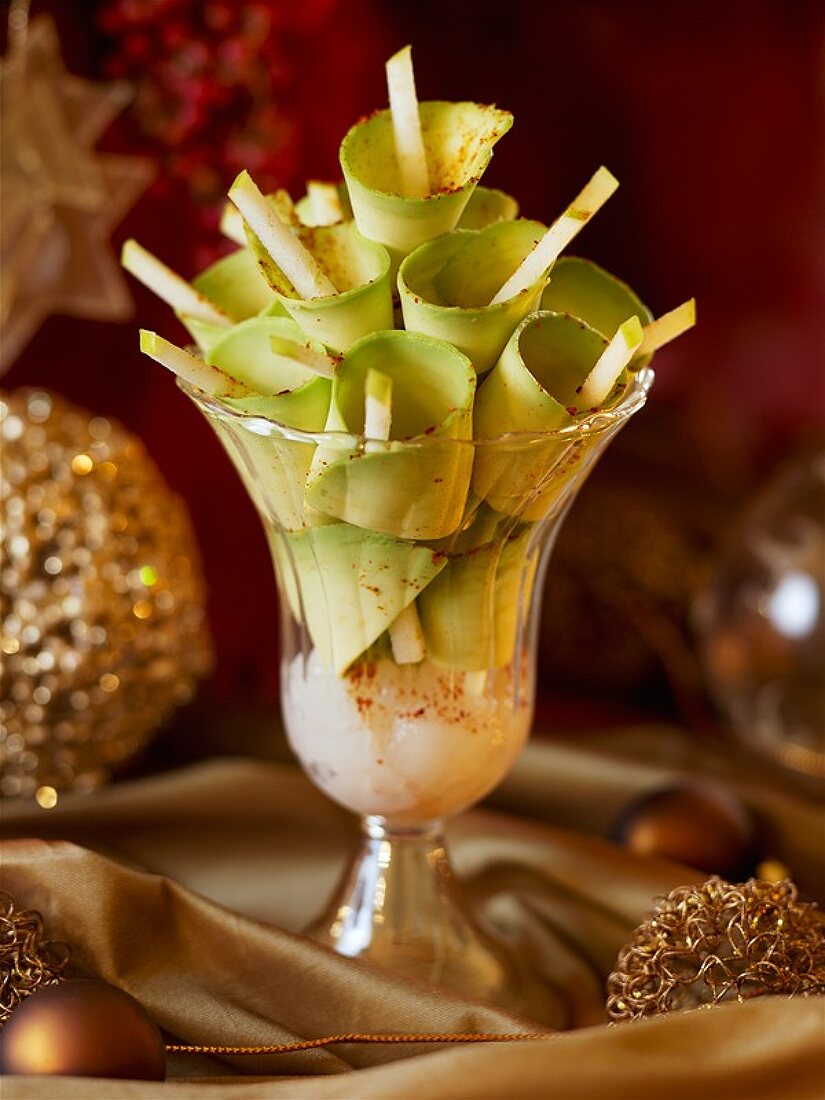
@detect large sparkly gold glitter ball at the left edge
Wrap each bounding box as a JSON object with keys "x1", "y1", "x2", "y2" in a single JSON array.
[{"x1": 0, "y1": 391, "x2": 212, "y2": 806}]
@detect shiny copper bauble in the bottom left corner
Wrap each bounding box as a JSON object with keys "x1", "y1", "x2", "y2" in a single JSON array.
[{"x1": 0, "y1": 978, "x2": 166, "y2": 1081}]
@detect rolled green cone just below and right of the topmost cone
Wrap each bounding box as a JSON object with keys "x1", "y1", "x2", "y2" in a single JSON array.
[{"x1": 398, "y1": 218, "x2": 546, "y2": 374}]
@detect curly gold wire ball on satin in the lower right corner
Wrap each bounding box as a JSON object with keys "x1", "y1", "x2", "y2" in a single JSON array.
[{"x1": 607, "y1": 878, "x2": 825, "y2": 1021}]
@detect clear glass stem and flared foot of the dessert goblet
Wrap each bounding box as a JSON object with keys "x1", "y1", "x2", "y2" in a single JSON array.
[{"x1": 307, "y1": 816, "x2": 563, "y2": 1025}]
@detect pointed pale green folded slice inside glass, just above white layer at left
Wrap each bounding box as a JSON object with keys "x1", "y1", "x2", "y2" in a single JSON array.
[{"x1": 272, "y1": 524, "x2": 447, "y2": 675}]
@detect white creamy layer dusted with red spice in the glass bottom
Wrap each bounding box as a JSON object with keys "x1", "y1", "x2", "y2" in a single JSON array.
[{"x1": 283, "y1": 651, "x2": 531, "y2": 825}]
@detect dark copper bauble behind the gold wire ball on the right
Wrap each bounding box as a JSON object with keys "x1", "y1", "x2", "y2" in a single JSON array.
[{"x1": 613, "y1": 783, "x2": 754, "y2": 879}]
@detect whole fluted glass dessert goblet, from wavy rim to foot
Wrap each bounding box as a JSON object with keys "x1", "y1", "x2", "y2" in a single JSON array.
[{"x1": 180, "y1": 369, "x2": 653, "y2": 1020}]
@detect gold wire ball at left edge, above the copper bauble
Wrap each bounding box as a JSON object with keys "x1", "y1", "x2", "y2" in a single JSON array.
[{"x1": 0, "y1": 892, "x2": 69, "y2": 1026}]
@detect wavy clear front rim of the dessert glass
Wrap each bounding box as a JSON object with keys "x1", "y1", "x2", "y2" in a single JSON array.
[{"x1": 176, "y1": 366, "x2": 656, "y2": 450}]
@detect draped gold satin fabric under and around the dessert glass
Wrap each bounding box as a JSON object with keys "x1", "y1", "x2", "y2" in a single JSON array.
[{"x1": 0, "y1": 729, "x2": 825, "y2": 1100}]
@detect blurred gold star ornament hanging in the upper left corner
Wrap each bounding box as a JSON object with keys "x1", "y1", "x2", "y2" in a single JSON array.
[{"x1": 0, "y1": 2, "x2": 154, "y2": 371}]
